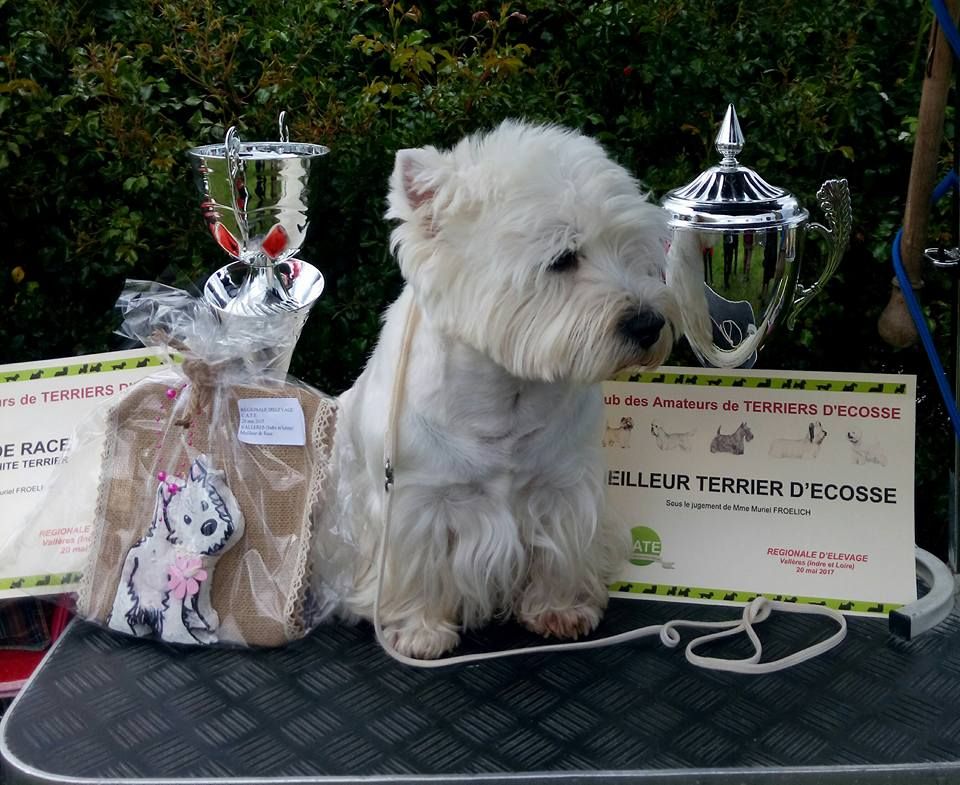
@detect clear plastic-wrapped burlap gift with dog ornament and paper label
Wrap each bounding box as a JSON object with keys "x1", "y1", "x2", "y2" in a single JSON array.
[{"x1": 37, "y1": 282, "x2": 336, "y2": 646}]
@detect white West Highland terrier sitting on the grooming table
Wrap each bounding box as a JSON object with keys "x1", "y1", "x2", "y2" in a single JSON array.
[{"x1": 314, "y1": 121, "x2": 702, "y2": 658}]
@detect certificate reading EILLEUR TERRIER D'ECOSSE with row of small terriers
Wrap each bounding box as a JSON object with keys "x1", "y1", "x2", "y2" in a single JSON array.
[{"x1": 603, "y1": 368, "x2": 916, "y2": 615}]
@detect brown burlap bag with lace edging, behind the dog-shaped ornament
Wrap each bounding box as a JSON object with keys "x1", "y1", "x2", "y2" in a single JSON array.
[{"x1": 77, "y1": 370, "x2": 336, "y2": 646}]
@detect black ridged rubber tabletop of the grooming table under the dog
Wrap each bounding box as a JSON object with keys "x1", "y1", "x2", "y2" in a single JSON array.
[{"x1": 2, "y1": 600, "x2": 960, "y2": 783}]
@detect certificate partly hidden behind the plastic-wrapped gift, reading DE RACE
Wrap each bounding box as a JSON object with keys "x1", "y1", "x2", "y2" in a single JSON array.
[{"x1": 0, "y1": 349, "x2": 164, "y2": 599}]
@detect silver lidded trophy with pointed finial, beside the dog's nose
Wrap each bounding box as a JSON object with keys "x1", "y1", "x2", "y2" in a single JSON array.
[{"x1": 661, "y1": 104, "x2": 852, "y2": 368}]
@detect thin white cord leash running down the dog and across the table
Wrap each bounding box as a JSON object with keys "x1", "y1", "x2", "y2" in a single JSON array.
[{"x1": 373, "y1": 300, "x2": 847, "y2": 674}]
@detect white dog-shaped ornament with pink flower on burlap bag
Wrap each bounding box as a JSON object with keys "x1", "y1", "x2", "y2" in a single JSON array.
[{"x1": 108, "y1": 455, "x2": 244, "y2": 644}]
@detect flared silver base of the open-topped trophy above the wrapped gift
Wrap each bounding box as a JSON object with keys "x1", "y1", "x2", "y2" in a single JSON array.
[{"x1": 203, "y1": 259, "x2": 324, "y2": 376}]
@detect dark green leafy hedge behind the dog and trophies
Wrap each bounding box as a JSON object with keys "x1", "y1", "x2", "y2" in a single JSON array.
[{"x1": 0, "y1": 0, "x2": 952, "y2": 544}]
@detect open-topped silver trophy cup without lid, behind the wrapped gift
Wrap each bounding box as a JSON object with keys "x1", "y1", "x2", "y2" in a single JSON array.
[{"x1": 189, "y1": 113, "x2": 329, "y2": 374}]
